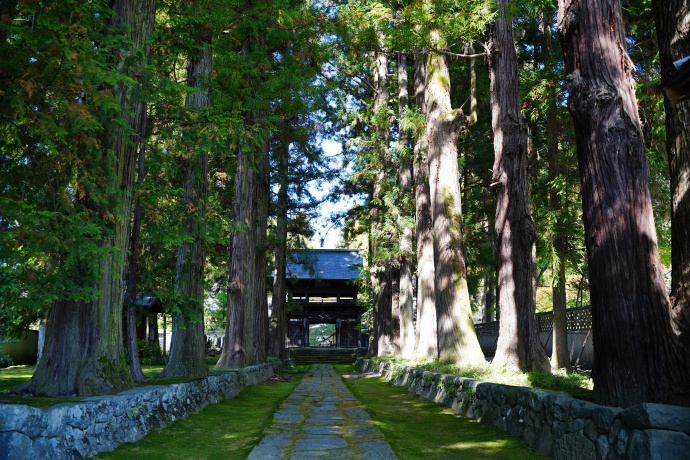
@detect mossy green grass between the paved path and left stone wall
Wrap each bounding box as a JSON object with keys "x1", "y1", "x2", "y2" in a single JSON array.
[{"x1": 94, "y1": 372, "x2": 299, "y2": 460}]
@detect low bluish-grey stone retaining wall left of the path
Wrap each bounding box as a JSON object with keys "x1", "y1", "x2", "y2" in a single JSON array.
[{"x1": 0, "y1": 363, "x2": 280, "y2": 460}]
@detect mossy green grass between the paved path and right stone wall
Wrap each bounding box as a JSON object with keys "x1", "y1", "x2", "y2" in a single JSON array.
[{"x1": 334, "y1": 365, "x2": 542, "y2": 460}]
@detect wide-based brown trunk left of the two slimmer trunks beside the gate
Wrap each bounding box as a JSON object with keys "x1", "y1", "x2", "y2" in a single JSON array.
[{"x1": 215, "y1": 148, "x2": 256, "y2": 369}]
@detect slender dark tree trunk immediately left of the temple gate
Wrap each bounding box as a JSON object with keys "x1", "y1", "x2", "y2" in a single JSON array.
[{"x1": 268, "y1": 138, "x2": 290, "y2": 358}]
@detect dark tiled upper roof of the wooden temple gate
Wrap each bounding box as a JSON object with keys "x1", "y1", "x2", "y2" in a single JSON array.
[{"x1": 287, "y1": 249, "x2": 363, "y2": 280}]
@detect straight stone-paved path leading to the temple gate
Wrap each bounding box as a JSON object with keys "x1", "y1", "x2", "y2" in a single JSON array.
[{"x1": 247, "y1": 364, "x2": 397, "y2": 460}]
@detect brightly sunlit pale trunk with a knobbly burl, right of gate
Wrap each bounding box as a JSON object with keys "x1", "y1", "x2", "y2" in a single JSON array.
[{"x1": 426, "y1": 30, "x2": 484, "y2": 364}]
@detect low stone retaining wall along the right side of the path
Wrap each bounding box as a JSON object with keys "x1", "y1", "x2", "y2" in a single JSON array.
[{"x1": 358, "y1": 359, "x2": 690, "y2": 460}]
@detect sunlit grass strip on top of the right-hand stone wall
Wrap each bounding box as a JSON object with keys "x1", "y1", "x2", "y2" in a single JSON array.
[{"x1": 371, "y1": 355, "x2": 594, "y2": 399}]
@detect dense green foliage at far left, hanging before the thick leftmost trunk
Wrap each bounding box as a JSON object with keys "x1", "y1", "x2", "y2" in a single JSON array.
[{"x1": 0, "y1": 0, "x2": 133, "y2": 330}]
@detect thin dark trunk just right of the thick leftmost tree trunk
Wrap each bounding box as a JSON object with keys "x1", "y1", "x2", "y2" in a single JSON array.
[{"x1": 127, "y1": 110, "x2": 146, "y2": 382}]
